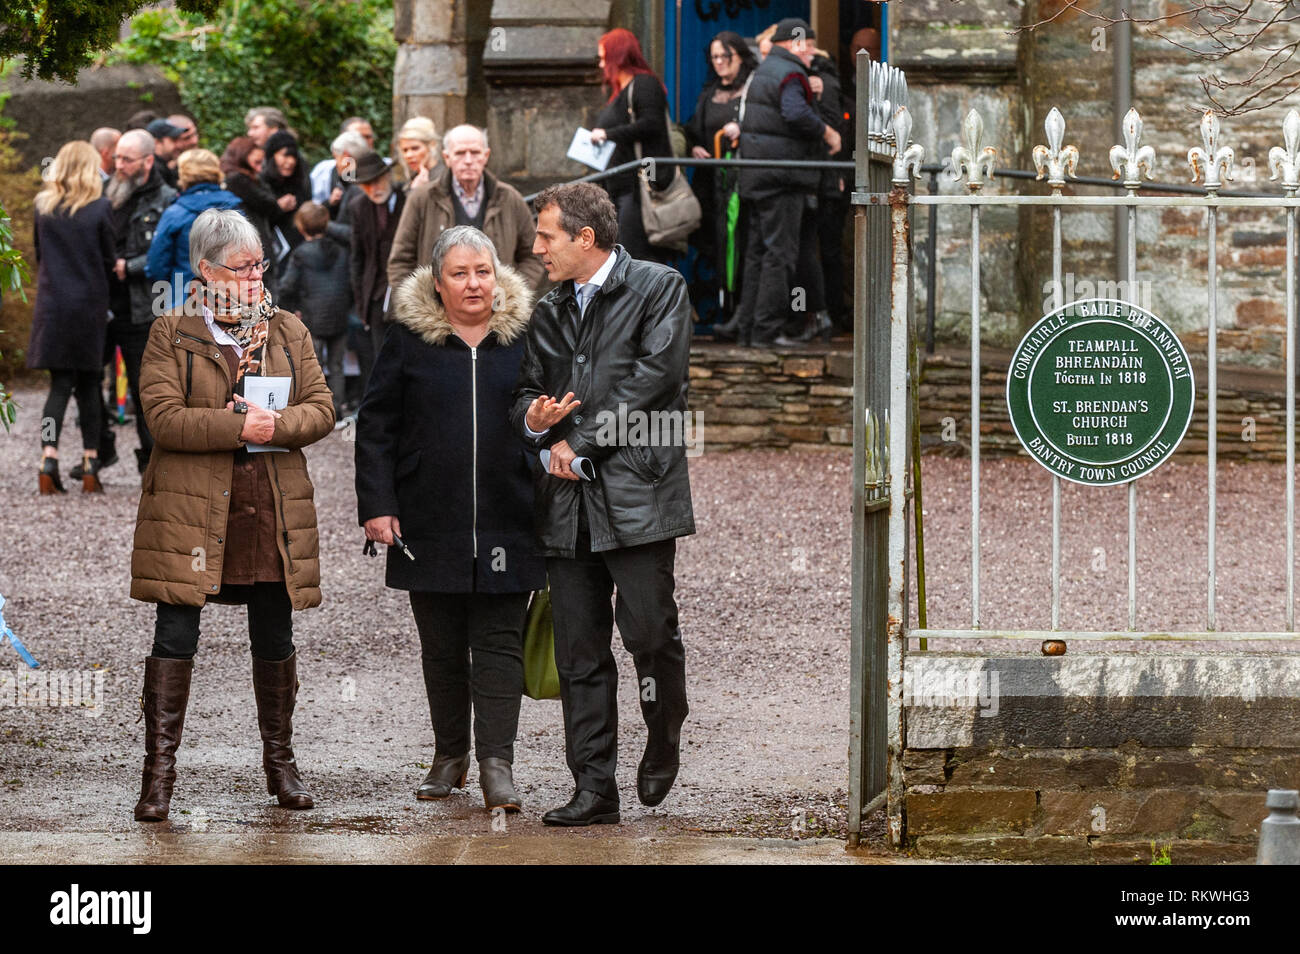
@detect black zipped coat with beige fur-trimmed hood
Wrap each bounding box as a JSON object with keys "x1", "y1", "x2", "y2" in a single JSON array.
[{"x1": 356, "y1": 257, "x2": 546, "y2": 593}]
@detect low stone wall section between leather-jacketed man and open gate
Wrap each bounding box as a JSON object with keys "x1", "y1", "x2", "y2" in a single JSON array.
[{"x1": 690, "y1": 344, "x2": 853, "y2": 451}]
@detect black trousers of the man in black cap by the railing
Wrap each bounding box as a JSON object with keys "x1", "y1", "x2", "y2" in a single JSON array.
[{"x1": 740, "y1": 192, "x2": 807, "y2": 344}]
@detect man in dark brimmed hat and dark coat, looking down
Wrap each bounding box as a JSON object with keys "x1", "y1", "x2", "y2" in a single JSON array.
[{"x1": 339, "y1": 149, "x2": 407, "y2": 394}]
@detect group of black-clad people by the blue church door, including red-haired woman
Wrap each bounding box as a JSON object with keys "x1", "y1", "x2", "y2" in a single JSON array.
[{"x1": 592, "y1": 17, "x2": 879, "y2": 347}]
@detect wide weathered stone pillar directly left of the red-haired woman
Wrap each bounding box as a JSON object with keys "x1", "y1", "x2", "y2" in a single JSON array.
[{"x1": 482, "y1": 0, "x2": 611, "y2": 194}]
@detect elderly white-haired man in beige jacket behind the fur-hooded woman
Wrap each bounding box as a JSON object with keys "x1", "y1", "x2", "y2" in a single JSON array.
[{"x1": 389, "y1": 126, "x2": 543, "y2": 289}]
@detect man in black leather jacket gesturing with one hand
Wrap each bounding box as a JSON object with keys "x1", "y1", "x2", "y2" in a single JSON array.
[{"x1": 511, "y1": 183, "x2": 696, "y2": 825}]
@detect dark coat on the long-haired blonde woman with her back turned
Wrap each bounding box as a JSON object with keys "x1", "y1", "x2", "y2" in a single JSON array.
[{"x1": 27, "y1": 196, "x2": 117, "y2": 370}]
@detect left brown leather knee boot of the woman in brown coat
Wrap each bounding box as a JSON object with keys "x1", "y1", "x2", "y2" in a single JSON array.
[{"x1": 135, "y1": 656, "x2": 194, "y2": 821}]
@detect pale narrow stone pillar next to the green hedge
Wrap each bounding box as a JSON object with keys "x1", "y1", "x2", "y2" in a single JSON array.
[{"x1": 393, "y1": 0, "x2": 485, "y2": 135}]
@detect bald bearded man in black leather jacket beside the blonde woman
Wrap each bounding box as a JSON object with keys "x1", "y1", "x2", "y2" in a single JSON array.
[{"x1": 99, "y1": 129, "x2": 177, "y2": 473}]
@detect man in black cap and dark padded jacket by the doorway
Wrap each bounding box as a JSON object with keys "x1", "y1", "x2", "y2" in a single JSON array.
[{"x1": 737, "y1": 17, "x2": 840, "y2": 347}]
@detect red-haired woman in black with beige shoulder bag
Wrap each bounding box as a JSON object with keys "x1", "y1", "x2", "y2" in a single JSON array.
[{"x1": 592, "y1": 29, "x2": 673, "y2": 263}]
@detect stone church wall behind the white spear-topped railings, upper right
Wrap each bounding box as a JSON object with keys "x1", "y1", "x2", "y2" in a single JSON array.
[{"x1": 891, "y1": 0, "x2": 1300, "y2": 368}]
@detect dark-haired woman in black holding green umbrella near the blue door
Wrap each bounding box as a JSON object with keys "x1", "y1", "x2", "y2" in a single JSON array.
[{"x1": 685, "y1": 30, "x2": 758, "y2": 328}]
